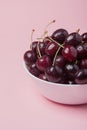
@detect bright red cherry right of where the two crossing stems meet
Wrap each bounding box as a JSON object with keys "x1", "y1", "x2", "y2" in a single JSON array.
[{"x1": 62, "y1": 45, "x2": 77, "y2": 62}]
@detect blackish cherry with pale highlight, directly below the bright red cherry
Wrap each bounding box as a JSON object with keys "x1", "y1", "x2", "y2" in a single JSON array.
[{"x1": 65, "y1": 63, "x2": 79, "y2": 80}]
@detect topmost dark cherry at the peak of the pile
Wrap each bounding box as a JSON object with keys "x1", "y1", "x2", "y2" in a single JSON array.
[{"x1": 52, "y1": 29, "x2": 68, "y2": 44}]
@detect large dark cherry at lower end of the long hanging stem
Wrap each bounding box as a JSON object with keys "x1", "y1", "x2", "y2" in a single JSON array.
[{"x1": 45, "y1": 66, "x2": 62, "y2": 82}]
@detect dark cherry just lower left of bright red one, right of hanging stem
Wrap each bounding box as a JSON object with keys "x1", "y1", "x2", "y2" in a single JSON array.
[{"x1": 54, "y1": 55, "x2": 66, "y2": 68}]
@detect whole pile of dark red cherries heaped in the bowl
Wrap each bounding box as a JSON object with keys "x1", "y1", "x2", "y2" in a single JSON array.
[{"x1": 23, "y1": 20, "x2": 87, "y2": 84}]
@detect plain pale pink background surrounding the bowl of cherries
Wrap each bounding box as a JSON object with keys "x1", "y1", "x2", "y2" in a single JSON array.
[{"x1": 0, "y1": 0, "x2": 87, "y2": 130}]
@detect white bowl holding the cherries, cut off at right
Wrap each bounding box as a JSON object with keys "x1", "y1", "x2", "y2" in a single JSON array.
[{"x1": 23, "y1": 64, "x2": 87, "y2": 105}]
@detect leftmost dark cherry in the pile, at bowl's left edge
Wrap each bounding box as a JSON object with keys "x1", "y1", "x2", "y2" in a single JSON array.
[{"x1": 24, "y1": 50, "x2": 37, "y2": 65}]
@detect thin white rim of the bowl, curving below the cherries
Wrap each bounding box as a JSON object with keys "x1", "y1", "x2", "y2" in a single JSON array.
[{"x1": 23, "y1": 61, "x2": 87, "y2": 87}]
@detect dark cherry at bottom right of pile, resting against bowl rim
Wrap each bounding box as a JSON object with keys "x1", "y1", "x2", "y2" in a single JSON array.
[{"x1": 75, "y1": 69, "x2": 87, "y2": 84}]
